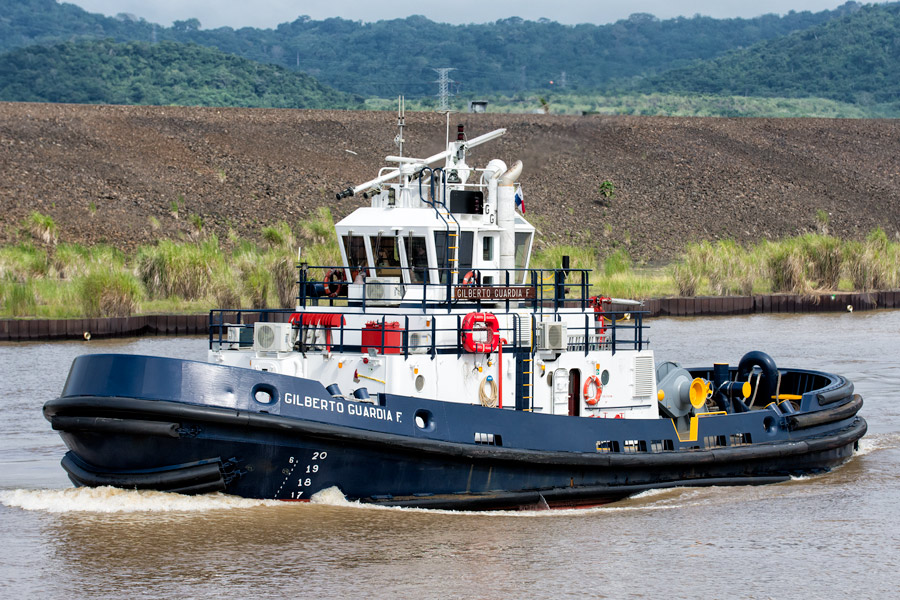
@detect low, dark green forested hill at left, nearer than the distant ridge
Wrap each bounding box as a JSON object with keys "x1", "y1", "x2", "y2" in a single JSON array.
[{"x1": 0, "y1": 40, "x2": 362, "y2": 108}]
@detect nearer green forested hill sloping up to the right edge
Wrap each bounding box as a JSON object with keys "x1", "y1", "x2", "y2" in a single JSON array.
[{"x1": 641, "y1": 3, "x2": 900, "y2": 105}]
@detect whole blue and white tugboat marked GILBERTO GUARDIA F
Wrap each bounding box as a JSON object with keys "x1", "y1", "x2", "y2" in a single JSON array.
[{"x1": 43, "y1": 114, "x2": 866, "y2": 509}]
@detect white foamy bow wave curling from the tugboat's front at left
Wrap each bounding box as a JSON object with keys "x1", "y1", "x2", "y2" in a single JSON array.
[{"x1": 0, "y1": 487, "x2": 281, "y2": 513}]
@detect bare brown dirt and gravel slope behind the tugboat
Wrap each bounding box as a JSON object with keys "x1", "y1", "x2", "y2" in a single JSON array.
[{"x1": 0, "y1": 103, "x2": 900, "y2": 261}]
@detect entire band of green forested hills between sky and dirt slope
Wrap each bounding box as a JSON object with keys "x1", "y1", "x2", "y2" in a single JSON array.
[{"x1": 0, "y1": 0, "x2": 900, "y2": 118}]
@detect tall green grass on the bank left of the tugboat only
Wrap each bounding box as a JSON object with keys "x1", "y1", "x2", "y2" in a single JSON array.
[{"x1": 0, "y1": 209, "x2": 340, "y2": 318}]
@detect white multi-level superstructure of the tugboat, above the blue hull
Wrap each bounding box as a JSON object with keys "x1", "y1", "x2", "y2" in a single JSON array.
[{"x1": 210, "y1": 120, "x2": 659, "y2": 418}]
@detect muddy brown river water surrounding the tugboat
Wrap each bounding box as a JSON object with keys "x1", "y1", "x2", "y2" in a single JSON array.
[{"x1": 0, "y1": 311, "x2": 900, "y2": 600}]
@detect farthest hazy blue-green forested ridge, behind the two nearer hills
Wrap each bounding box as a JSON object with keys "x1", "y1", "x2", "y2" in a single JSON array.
[{"x1": 0, "y1": 0, "x2": 860, "y2": 97}]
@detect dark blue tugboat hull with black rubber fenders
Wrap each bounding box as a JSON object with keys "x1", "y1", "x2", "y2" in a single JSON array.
[{"x1": 44, "y1": 355, "x2": 866, "y2": 508}]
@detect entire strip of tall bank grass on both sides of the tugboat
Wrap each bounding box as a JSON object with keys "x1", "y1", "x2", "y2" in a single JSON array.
[{"x1": 0, "y1": 208, "x2": 900, "y2": 318}]
